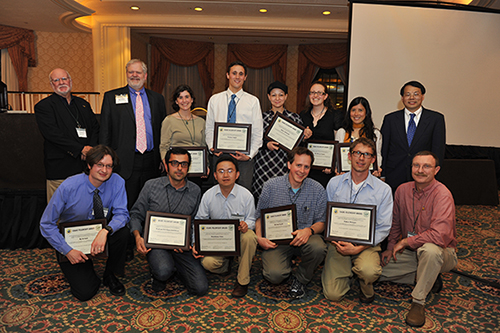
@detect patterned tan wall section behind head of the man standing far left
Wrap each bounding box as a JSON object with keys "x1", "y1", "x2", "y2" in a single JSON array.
[{"x1": 28, "y1": 31, "x2": 94, "y2": 92}]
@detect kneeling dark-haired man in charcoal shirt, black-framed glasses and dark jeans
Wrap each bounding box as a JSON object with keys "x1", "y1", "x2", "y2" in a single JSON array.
[{"x1": 129, "y1": 147, "x2": 208, "y2": 296}]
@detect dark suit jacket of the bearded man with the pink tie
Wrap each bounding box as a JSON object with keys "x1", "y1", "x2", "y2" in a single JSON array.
[{"x1": 99, "y1": 86, "x2": 167, "y2": 180}]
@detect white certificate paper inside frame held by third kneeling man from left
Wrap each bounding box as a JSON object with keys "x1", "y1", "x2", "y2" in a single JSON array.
[{"x1": 198, "y1": 224, "x2": 238, "y2": 252}]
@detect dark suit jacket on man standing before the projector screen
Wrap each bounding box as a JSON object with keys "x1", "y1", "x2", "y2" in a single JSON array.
[{"x1": 381, "y1": 108, "x2": 446, "y2": 191}]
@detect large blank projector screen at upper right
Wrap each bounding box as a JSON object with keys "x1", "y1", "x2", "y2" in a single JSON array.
[{"x1": 348, "y1": 3, "x2": 500, "y2": 147}]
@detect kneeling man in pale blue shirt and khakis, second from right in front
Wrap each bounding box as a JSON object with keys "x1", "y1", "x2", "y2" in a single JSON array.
[{"x1": 321, "y1": 138, "x2": 393, "y2": 303}]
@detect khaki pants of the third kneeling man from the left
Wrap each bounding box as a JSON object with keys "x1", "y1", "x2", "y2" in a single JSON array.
[{"x1": 201, "y1": 229, "x2": 257, "y2": 286}]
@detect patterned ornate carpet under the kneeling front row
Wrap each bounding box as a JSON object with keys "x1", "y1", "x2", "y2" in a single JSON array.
[{"x1": 0, "y1": 200, "x2": 500, "y2": 333}]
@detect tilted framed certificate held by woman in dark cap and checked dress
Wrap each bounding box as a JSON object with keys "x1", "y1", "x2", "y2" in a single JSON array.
[{"x1": 264, "y1": 112, "x2": 305, "y2": 151}]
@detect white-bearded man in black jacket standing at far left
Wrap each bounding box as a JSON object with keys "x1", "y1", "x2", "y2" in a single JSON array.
[{"x1": 35, "y1": 68, "x2": 99, "y2": 202}]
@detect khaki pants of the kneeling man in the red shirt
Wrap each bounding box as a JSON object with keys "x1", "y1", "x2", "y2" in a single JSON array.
[{"x1": 379, "y1": 243, "x2": 457, "y2": 304}]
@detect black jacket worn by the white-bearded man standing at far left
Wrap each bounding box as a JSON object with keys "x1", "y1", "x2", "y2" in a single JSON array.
[{"x1": 35, "y1": 93, "x2": 99, "y2": 180}]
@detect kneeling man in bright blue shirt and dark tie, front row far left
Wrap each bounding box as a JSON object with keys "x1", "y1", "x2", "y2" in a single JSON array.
[{"x1": 40, "y1": 145, "x2": 129, "y2": 301}]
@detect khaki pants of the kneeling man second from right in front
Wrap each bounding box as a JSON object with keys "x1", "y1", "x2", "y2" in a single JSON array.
[{"x1": 321, "y1": 244, "x2": 382, "y2": 302}]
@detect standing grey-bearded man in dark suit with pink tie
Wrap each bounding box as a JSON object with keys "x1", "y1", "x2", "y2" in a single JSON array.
[{"x1": 99, "y1": 59, "x2": 166, "y2": 206}]
